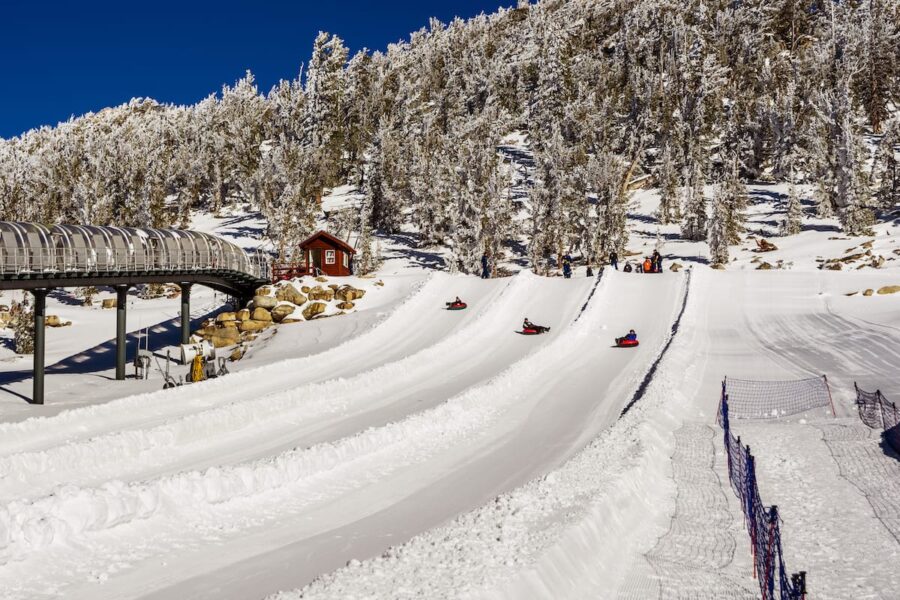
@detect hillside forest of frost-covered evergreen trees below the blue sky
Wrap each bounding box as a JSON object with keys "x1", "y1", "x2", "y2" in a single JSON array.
[{"x1": 0, "y1": 0, "x2": 900, "y2": 272}]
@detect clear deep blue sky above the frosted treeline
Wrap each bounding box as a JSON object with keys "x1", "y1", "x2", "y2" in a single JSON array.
[{"x1": 0, "y1": 0, "x2": 515, "y2": 137}]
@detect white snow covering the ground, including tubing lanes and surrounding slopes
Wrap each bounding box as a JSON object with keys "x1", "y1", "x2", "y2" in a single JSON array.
[{"x1": 0, "y1": 158, "x2": 900, "y2": 599}]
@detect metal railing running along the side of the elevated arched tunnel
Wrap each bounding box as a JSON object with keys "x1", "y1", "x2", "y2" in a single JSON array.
[{"x1": 0, "y1": 246, "x2": 269, "y2": 279}]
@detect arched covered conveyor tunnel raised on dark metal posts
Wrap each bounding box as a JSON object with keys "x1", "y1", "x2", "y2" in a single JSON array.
[{"x1": 0, "y1": 221, "x2": 269, "y2": 404}]
